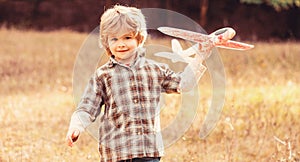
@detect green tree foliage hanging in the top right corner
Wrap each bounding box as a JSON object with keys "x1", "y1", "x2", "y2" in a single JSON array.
[{"x1": 240, "y1": 0, "x2": 300, "y2": 11}]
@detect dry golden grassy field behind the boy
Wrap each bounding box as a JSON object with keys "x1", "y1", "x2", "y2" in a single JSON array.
[{"x1": 0, "y1": 29, "x2": 300, "y2": 162}]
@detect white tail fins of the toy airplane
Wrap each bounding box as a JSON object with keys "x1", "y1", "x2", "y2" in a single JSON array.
[{"x1": 154, "y1": 39, "x2": 198, "y2": 63}]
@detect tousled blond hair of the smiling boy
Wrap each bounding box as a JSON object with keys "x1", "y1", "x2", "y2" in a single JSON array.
[{"x1": 99, "y1": 5, "x2": 147, "y2": 55}]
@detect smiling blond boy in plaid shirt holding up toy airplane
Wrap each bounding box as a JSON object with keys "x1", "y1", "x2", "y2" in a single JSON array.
[{"x1": 66, "y1": 5, "x2": 210, "y2": 162}]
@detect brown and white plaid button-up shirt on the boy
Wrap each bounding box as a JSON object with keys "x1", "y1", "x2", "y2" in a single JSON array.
[{"x1": 70, "y1": 50, "x2": 206, "y2": 162}]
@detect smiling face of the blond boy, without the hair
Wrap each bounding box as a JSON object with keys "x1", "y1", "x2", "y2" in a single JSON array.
[{"x1": 108, "y1": 32, "x2": 138, "y2": 64}]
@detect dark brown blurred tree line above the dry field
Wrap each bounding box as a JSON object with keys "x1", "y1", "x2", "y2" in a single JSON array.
[{"x1": 0, "y1": 0, "x2": 300, "y2": 40}]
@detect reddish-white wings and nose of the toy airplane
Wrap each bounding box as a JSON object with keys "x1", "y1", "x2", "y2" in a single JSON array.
[{"x1": 158, "y1": 27, "x2": 254, "y2": 51}]
